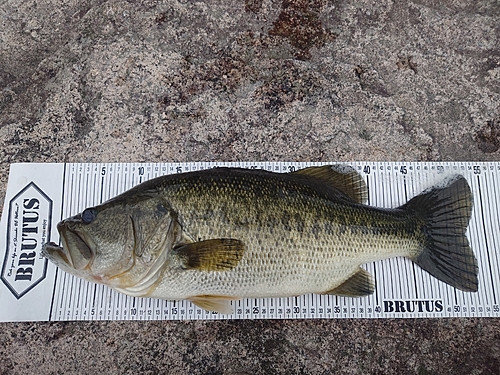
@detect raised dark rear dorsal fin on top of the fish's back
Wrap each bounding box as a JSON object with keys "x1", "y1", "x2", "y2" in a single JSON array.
[{"x1": 293, "y1": 164, "x2": 368, "y2": 203}]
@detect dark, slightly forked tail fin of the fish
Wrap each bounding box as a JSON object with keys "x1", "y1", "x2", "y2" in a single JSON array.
[{"x1": 401, "y1": 176, "x2": 478, "y2": 292}]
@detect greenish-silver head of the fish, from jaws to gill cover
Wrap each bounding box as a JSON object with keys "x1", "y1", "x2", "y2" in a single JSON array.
[{"x1": 43, "y1": 194, "x2": 182, "y2": 295}]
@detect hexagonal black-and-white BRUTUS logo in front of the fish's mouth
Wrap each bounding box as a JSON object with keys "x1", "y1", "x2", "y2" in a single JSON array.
[{"x1": 1, "y1": 182, "x2": 52, "y2": 299}]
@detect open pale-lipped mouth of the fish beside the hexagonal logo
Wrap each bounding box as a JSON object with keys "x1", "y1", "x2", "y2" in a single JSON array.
[{"x1": 42, "y1": 222, "x2": 94, "y2": 270}]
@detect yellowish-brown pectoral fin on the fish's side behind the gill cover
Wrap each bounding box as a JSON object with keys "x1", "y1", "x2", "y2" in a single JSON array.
[{"x1": 173, "y1": 238, "x2": 245, "y2": 271}]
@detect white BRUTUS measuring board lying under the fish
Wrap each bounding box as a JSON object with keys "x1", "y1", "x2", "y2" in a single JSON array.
[{"x1": 0, "y1": 162, "x2": 500, "y2": 321}]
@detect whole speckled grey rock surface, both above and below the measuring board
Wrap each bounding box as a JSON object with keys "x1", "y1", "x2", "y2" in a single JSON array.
[{"x1": 0, "y1": 0, "x2": 500, "y2": 374}]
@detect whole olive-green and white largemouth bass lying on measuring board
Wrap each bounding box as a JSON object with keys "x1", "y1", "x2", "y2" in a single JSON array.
[{"x1": 42, "y1": 164, "x2": 478, "y2": 314}]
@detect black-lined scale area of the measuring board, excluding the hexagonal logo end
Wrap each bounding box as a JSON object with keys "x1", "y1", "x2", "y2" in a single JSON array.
[{"x1": 15, "y1": 162, "x2": 500, "y2": 320}]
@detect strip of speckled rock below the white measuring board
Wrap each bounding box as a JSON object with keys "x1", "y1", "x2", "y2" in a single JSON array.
[{"x1": 0, "y1": 319, "x2": 500, "y2": 375}]
